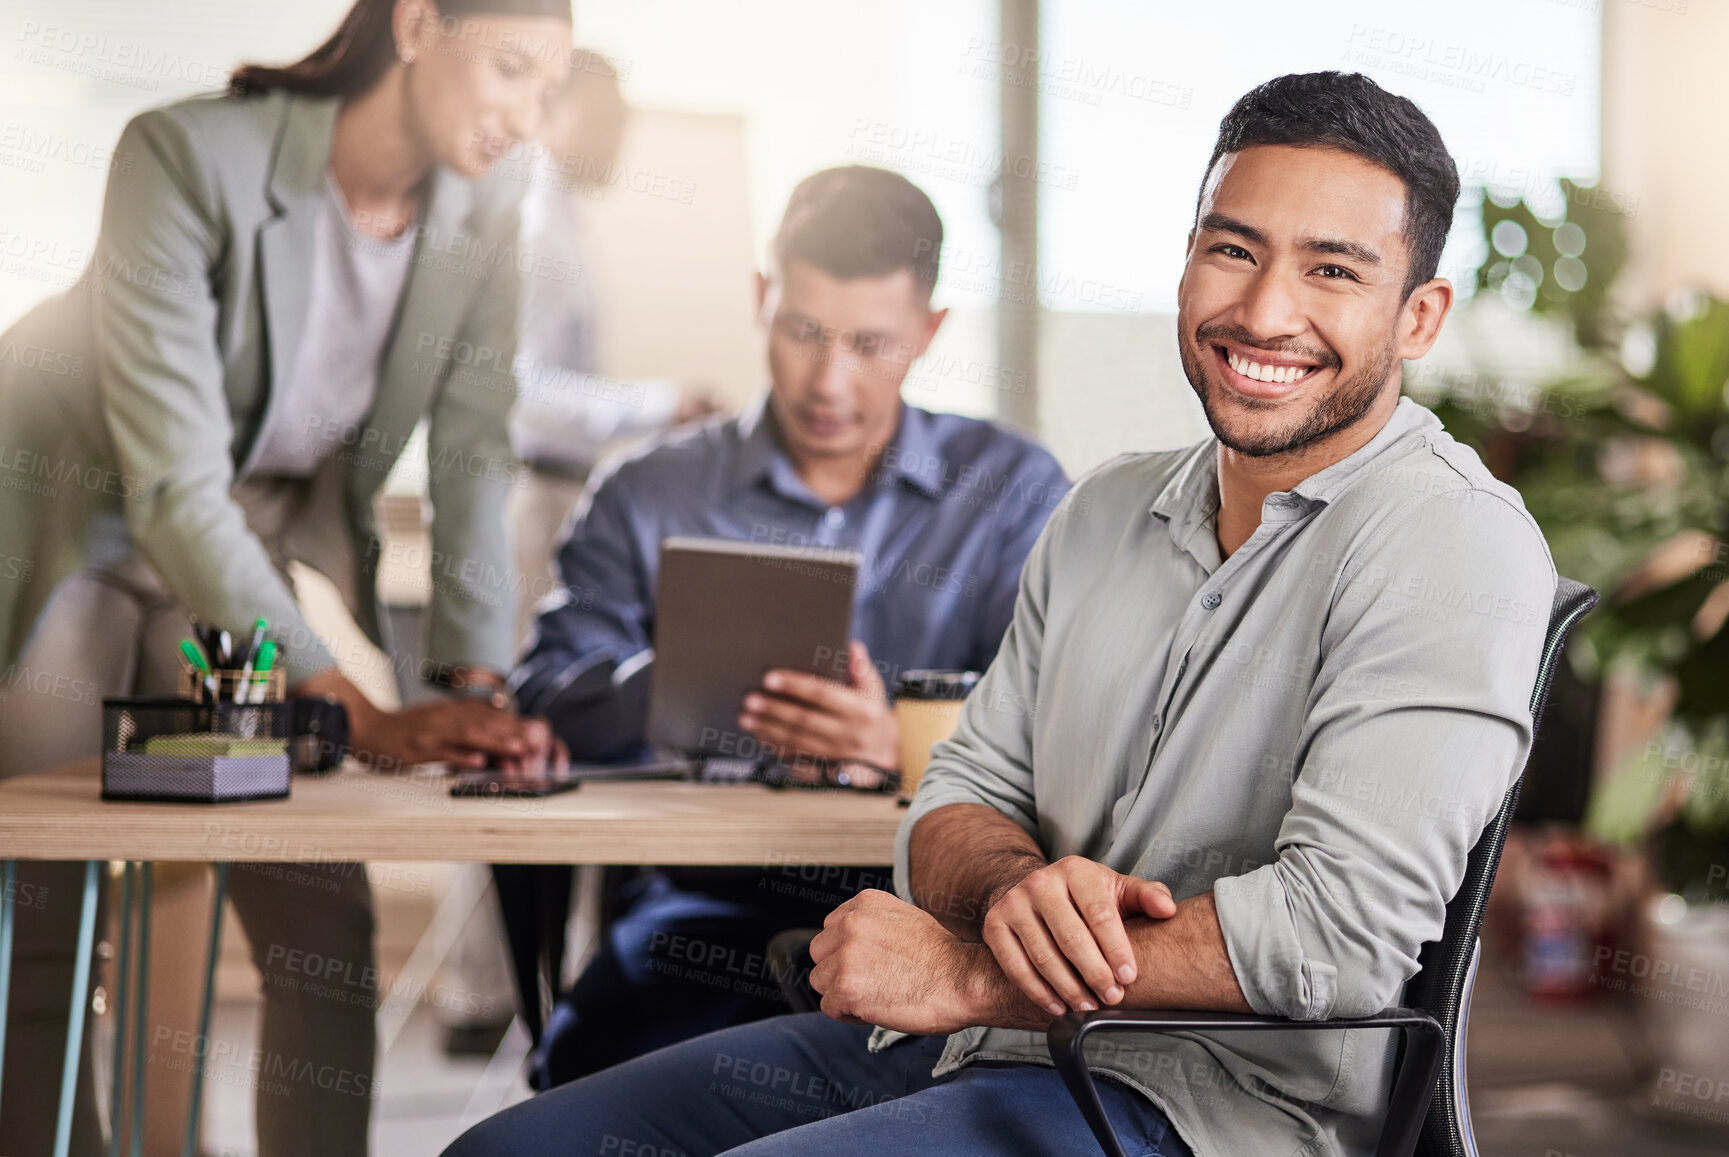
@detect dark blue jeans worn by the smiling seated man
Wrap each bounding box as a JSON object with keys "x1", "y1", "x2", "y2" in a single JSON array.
[{"x1": 444, "y1": 1012, "x2": 1193, "y2": 1157}]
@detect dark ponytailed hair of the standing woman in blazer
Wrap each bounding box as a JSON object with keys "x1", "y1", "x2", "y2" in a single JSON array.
[{"x1": 228, "y1": 0, "x2": 571, "y2": 97}]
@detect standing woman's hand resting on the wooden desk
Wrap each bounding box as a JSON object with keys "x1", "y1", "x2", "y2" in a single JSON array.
[{"x1": 296, "y1": 669, "x2": 564, "y2": 768}]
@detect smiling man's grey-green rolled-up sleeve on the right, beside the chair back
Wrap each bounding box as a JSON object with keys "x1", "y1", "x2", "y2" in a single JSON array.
[{"x1": 1214, "y1": 489, "x2": 1554, "y2": 1020}]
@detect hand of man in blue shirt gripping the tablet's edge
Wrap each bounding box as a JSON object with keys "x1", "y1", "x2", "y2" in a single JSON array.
[{"x1": 738, "y1": 640, "x2": 901, "y2": 770}]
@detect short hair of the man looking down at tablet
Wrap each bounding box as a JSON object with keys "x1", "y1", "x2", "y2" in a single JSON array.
[{"x1": 773, "y1": 164, "x2": 942, "y2": 301}]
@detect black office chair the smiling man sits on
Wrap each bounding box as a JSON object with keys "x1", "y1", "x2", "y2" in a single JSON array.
[{"x1": 768, "y1": 578, "x2": 1598, "y2": 1157}]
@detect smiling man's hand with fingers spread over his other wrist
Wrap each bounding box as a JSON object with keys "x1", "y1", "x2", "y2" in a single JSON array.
[{"x1": 984, "y1": 856, "x2": 1177, "y2": 1015}]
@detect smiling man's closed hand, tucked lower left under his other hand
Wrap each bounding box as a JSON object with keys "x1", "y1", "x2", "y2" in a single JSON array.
[{"x1": 811, "y1": 889, "x2": 999, "y2": 1036}]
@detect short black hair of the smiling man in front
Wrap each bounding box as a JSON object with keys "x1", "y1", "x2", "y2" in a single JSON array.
[{"x1": 1195, "y1": 73, "x2": 1459, "y2": 297}]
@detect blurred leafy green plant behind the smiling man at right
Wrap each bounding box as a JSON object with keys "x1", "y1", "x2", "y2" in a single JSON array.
[{"x1": 1407, "y1": 182, "x2": 1729, "y2": 1121}]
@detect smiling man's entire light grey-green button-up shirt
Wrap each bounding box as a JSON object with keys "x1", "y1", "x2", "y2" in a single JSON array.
[{"x1": 873, "y1": 400, "x2": 1556, "y2": 1157}]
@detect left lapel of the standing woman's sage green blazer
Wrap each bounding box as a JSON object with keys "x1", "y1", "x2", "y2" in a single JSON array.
[{"x1": 240, "y1": 97, "x2": 337, "y2": 476}]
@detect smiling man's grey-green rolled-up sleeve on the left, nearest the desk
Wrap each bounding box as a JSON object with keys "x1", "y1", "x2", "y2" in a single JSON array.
[{"x1": 894, "y1": 491, "x2": 1063, "y2": 901}]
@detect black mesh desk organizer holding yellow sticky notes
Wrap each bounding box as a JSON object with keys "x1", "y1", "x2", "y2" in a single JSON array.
[{"x1": 102, "y1": 697, "x2": 292, "y2": 802}]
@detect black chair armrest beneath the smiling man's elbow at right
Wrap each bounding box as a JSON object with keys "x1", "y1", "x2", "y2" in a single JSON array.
[{"x1": 1044, "y1": 1007, "x2": 1444, "y2": 1157}]
